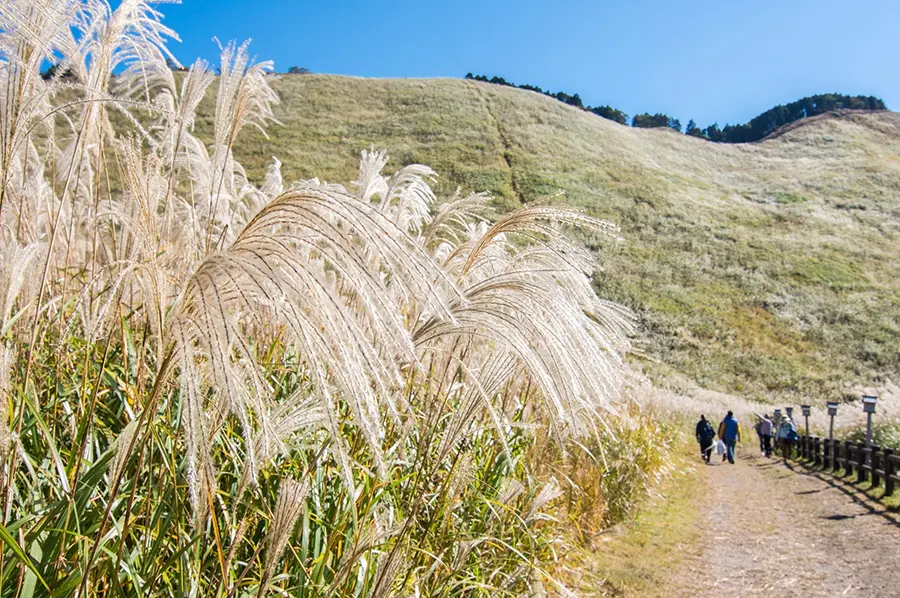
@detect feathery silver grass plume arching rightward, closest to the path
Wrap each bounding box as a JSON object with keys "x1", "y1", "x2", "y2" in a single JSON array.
[{"x1": 413, "y1": 206, "x2": 631, "y2": 438}]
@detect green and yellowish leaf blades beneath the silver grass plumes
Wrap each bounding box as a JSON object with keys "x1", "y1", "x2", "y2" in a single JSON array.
[{"x1": 0, "y1": 330, "x2": 672, "y2": 598}]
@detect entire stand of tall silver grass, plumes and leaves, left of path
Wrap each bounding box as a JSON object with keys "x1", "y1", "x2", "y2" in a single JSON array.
[{"x1": 0, "y1": 0, "x2": 664, "y2": 597}]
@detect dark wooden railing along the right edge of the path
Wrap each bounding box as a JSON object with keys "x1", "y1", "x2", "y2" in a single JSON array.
[{"x1": 793, "y1": 436, "x2": 900, "y2": 496}]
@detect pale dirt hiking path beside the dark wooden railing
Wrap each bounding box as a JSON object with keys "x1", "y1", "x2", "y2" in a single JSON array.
[{"x1": 672, "y1": 452, "x2": 900, "y2": 598}]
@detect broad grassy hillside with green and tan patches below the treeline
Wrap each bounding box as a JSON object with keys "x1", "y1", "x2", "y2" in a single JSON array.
[{"x1": 198, "y1": 75, "x2": 900, "y2": 400}]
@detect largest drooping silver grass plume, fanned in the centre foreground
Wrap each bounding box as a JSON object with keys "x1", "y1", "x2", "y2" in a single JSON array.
[{"x1": 170, "y1": 187, "x2": 458, "y2": 510}]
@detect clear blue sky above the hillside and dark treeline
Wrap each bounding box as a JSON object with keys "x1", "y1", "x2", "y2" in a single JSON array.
[{"x1": 159, "y1": 0, "x2": 900, "y2": 126}]
